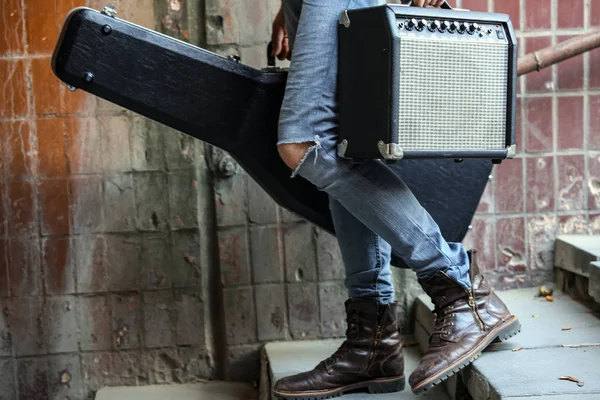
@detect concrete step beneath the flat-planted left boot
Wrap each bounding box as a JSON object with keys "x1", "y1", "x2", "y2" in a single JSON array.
[{"x1": 260, "y1": 339, "x2": 449, "y2": 400}]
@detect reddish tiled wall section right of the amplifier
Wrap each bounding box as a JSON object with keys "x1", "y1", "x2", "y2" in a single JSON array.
[{"x1": 450, "y1": 0, "x2": 600, "y2": 289}]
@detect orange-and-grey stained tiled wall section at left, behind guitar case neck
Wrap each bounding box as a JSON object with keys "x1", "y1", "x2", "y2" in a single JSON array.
[{"x1": 0, "y1": 0, "x2": 219, "y2": 399}]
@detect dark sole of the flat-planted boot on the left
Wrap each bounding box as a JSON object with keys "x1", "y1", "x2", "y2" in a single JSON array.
[{"x1": 273, "y1": 375, "x2": 406, "y2": 400}]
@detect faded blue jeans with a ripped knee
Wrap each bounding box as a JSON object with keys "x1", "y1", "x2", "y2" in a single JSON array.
[{"x1": 278, "y1": 0, "x2": 470, "y2": 303}]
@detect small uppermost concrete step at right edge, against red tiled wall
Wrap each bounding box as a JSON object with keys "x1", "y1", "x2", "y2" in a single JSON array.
[{"x1": 554, "y1": 235, "x2": 600, "y2": 303}]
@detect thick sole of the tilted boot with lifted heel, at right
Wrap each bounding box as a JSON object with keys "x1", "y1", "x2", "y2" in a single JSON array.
[{"x1": 412, "y1": 315, "x2": 521, "y2": 394}]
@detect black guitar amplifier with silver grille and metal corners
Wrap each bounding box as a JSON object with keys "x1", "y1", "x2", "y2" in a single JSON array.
[{"x1": 338, "y1": 5, "x2": 517, "y2": 163}]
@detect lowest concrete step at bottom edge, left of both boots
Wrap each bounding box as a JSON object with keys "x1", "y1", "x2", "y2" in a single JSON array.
[{"x1": 96, "y1": 382, "x2": 258, "y2": 400}]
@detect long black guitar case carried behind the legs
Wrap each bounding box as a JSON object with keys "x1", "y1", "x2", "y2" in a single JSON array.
[{"x1": 52, "y1": 8, "x2": 492, "y2": 268}]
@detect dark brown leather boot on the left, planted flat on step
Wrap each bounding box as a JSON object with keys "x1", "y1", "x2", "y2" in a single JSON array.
[{"x1": 273, "y1": 299, "x2": 405, "y2": 400}]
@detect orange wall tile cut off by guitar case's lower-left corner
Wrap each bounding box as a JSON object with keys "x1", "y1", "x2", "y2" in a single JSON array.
[{"x1": 31, "y1": 58, "x2": 61, "y2": 114}]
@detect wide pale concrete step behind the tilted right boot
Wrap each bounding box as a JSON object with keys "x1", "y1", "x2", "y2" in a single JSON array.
[{"x1": 415, "y1": 288, "x2": 600, "y2": 400}]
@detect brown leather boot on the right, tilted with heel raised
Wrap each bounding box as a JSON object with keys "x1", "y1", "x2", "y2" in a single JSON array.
[{"x1": 409, "y1": 250, "x2": 521, "y2": 393}]
